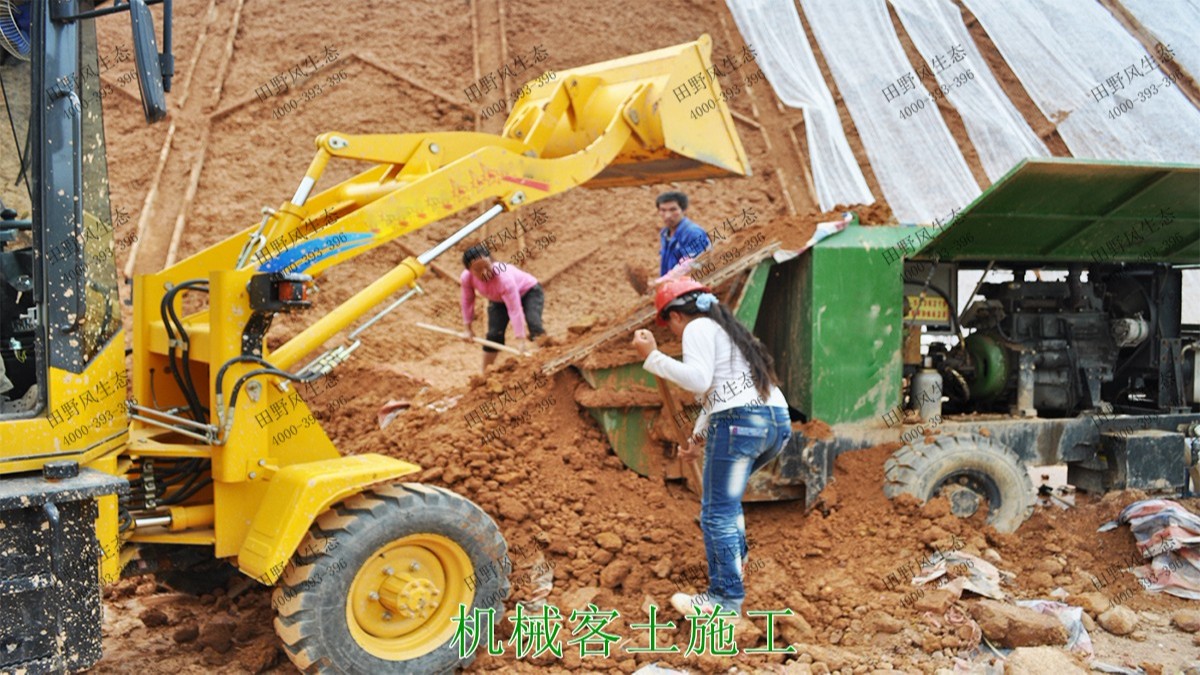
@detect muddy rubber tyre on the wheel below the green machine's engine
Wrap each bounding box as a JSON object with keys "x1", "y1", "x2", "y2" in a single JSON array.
[{"x1": 883, "y1": 435, "x2": 1033, "y2": 532}]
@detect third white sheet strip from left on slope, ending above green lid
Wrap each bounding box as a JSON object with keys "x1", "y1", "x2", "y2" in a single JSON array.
[{"x1": 892, "y1": 0, "x2": 1050, "y2": 181}]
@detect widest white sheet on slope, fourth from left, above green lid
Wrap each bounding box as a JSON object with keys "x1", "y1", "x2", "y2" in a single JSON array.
[{"x1": 964, "y1": 0, "x2": 1200, "y2": 162}]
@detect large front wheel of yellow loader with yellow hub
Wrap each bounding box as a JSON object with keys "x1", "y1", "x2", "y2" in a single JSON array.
[{"x1": 271, "y1": 483, "x2": 509, "y2": 674}]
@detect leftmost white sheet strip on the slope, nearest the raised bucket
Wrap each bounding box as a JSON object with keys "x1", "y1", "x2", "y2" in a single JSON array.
[{"x1": 726, "y1": 0, "x2": 875, "y2": 210}]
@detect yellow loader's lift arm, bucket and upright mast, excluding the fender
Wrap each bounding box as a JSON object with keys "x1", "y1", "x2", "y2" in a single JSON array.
[{"x1": 134, "y1": 36, "x2": 749, "y2": 443}]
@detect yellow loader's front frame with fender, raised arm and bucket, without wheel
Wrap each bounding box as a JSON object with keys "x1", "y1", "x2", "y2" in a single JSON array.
[{"x1": 124, "y1": 36, "x2": 749, "y2": 583}]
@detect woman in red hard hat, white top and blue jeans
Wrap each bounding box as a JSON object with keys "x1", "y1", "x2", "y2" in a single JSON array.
[{"x1": 634, "y1": 277, "x2": 791, "y2": 616}]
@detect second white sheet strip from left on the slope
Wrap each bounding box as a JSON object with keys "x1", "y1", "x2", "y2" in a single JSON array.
[{"x1": 802, "y1": 0, "x2": 979, "y2": 223}]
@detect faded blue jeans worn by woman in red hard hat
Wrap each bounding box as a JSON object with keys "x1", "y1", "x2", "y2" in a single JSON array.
[{"x1": 700, "y1": 406, "x2": 792, "y2": 614}]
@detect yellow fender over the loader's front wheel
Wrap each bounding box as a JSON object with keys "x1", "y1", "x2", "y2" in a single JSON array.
[{"x1": 238, "y1": 454, "x2": 421, "y2": 585}]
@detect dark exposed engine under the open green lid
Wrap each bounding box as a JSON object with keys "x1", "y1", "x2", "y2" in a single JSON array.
[{"x1": 928, "y1": 264, "x2": 1195, "y2": 417}]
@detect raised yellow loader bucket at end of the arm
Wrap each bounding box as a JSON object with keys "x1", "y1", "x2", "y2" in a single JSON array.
[{"x1": 504, "y1": 35, "x2": 750, "y2": 187}]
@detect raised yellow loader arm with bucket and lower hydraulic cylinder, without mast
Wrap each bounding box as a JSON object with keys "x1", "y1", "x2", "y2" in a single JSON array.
[{"x1": 223, "y1": 32, "x2": 749, "y2": 369}]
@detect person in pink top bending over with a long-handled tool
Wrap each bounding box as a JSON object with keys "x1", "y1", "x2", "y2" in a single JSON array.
[{"x1": 458, "y1": 244, "x2": 546, "y2": 372}]
